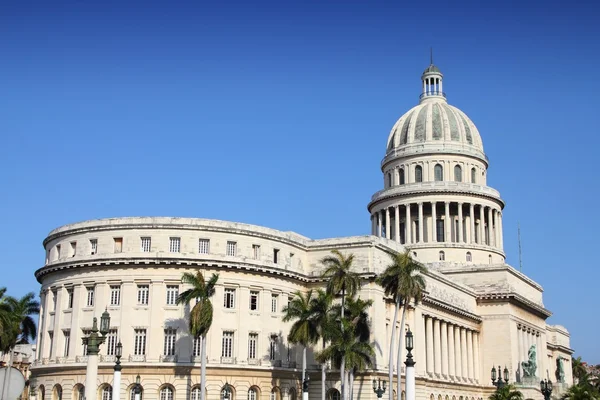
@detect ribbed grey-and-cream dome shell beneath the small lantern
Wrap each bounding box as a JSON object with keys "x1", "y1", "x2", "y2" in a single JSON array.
[{"x1": 387, "y1": 99, "x2": 483, "y2": 153}]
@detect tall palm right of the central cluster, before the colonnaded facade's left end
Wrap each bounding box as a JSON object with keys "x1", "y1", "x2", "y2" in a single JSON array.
[{"x1": 377, "y1": 250, "x2": 427, "y2": 400}]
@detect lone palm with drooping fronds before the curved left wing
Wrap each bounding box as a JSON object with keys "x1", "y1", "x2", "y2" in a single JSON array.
[{"x1": 177, "y1": 272, "x2": 219, "y2": 400}]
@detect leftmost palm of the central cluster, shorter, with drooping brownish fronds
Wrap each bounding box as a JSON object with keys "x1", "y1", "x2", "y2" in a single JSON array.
[{"x1": 283, "y1": 290, "x2": 319, "y2": 382}]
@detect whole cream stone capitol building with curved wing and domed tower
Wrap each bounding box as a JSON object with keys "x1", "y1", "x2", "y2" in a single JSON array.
[{"x1": 30, "y1": 65, "x2": 573, "y2": 400}]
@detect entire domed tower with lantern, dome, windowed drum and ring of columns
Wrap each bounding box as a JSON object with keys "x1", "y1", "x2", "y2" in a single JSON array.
[{"x1": 368, "y1": 63, "x2": 504, "y2": 266}]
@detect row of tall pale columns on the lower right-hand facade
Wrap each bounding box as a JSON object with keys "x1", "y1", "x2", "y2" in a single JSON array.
[{"x1": 423, "y1": 315, "x2": 480, "y2": 382}]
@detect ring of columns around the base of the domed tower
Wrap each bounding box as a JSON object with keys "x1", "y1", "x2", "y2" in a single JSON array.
[{"x1": 371, "y1": 201, "x2": 503, "y2": 249}]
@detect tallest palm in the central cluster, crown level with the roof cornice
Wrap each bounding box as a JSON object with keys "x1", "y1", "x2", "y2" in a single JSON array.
[{"x1": 321, "y1": 250, "x2": 360, "y2": 400}]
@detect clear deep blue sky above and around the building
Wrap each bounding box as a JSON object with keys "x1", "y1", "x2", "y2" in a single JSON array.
[{"x1": 0, "y1": 1, "x2": 600, "y2": 363}]
